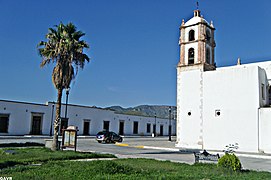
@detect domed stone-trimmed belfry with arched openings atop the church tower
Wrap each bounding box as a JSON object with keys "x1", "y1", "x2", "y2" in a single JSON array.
[{"x1": 178, "y1": 9, "x2": 216, "y2": 71}]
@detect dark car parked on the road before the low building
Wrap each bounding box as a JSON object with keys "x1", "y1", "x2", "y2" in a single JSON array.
[{"x1": 96, "y1": 131, "x2": 122, "y2": 143}]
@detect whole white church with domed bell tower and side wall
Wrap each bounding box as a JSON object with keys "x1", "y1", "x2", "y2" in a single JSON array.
[{"x1": 176, "y1": 9, "x2": 271, "y2": 153}]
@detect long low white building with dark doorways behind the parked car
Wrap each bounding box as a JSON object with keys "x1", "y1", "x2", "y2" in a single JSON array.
[{"x1": 0, "y1": 100, "x2": 176, "y2": 136}]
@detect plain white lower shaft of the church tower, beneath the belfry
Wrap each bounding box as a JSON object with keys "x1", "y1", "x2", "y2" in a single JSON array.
[{"x1": 176, "y1": 70, "x2": 202, "y2": 148}]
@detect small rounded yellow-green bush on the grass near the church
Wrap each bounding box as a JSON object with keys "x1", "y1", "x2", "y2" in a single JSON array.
[{"x1": 217, "y1": 153, "x2": 242, "y2": 171}]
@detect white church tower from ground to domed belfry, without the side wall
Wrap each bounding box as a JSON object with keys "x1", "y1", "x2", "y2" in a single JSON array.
[{"x1": 176, "y1": 9, "x2": 216, "y2": 149}]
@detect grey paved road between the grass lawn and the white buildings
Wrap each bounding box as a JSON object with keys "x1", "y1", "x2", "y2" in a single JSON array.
[{"x1": 0, "y1": 136, "x2": 271, "y2": 172}]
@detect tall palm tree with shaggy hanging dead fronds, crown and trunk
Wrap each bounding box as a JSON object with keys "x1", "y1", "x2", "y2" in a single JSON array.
[{"x1": 38, "y1": 23, "x2": 89, "y2": 151}]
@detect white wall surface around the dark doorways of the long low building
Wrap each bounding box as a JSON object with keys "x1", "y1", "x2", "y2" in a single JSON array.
[{"x1": 0, "y1": 100, "x2": 176, "y2": 135}]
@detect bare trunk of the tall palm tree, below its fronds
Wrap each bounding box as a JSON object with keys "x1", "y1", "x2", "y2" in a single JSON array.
[{"x1": 51, "y1": 88, "x2": 63, "y2": 151}]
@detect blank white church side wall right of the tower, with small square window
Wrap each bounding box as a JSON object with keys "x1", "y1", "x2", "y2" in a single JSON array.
[{"x1": 203, "y1": 66, "x2": 266, "y2": 152}]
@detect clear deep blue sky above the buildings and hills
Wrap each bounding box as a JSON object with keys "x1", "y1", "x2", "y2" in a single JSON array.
[{"x1": 0, "y1": 0, "x2": 271, "y2": 107}]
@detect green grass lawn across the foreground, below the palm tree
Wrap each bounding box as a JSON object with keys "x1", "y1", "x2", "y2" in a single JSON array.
[{"x1": 0, "y1": 149, "x2": 271, "y2": 180}]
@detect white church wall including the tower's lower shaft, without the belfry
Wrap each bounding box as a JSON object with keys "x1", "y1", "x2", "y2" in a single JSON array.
[{"x1": 176, "y1": 65, "x2": 269, "y2": 152}]
